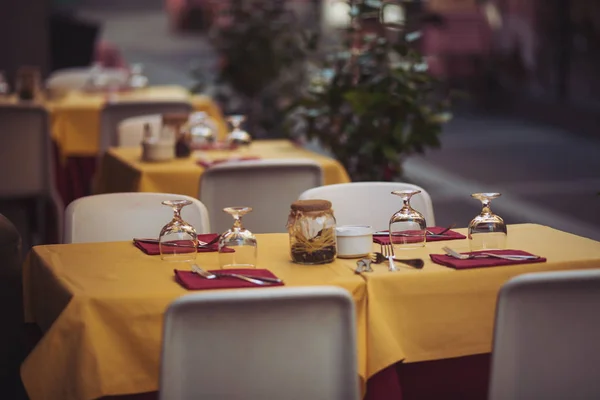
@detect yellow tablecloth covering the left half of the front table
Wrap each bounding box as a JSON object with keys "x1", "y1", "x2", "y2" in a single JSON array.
[{"x1": 21, "y1": 234, "x2": 367, "y2": 400}]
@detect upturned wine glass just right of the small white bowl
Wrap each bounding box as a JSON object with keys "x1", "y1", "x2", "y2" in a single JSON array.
[{"x1": 389, "y1": 190, "x2": 427, "y2": 250}]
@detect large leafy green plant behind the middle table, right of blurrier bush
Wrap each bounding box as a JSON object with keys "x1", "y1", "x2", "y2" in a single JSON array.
[{"x1": 286, "y1": 0, "x2": 451, "y2": 181}]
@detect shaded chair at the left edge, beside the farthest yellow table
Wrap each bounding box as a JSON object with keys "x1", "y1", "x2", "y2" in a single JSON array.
[{"x1": 0, "y1": 105, "x2": 64, "y2": 244}]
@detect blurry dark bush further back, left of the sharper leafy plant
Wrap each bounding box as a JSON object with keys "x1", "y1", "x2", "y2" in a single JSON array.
[{"x1": 205, "y1": 0, "x2": 316, "y2": 137}]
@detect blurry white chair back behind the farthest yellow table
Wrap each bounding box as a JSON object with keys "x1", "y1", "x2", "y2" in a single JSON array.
[{"x1": 46, "y1": 67, "x2": 129, "y2": 91}]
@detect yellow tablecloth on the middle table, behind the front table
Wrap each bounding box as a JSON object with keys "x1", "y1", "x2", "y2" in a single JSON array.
[{"x1": 96, "y1": 140, "x2": 350, "y2": 197}]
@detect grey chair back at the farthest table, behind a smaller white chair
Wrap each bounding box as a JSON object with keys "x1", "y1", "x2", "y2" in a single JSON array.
[{"x1": 100, "y1": 101, "x2": 192, "y2": 155}]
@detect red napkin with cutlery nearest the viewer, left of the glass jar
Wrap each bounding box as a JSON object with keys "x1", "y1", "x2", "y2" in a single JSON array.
[{"x1": 174, "y1": 268, "x2": 283, "y2": 290}]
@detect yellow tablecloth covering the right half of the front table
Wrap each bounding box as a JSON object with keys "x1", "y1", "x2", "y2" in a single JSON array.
[{"x1": 363, "y1": 224, "x2": 600, "y2": 377}]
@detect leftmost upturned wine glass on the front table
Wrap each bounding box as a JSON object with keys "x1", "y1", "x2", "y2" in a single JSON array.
[{"x1": 158, "y1": 200, "x2": 198, "y2": 262}]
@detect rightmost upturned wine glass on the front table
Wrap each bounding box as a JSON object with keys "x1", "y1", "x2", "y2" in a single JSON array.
[{"x1": 468, "y1": 193, "x2": 507, "y2": 251}]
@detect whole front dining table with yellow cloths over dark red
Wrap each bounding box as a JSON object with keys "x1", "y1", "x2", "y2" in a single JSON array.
[{"x1": 21, "y1": 224, "x2": 600, "y2": 400}]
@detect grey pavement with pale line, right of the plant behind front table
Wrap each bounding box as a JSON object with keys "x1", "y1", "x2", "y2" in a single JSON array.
[{"x1": 405, "y1": 112, "x2": 600, "y2": 240}]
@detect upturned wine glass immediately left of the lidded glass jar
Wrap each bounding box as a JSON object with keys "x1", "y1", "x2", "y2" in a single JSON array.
[{"x1": 219, "y1": 207, "x2": 257, "y2": 269}]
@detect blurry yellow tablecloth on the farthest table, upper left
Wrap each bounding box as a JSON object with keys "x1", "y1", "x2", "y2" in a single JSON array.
[{"x1": 45, "y1": 86, "x2": 227, "y2": 157}]
